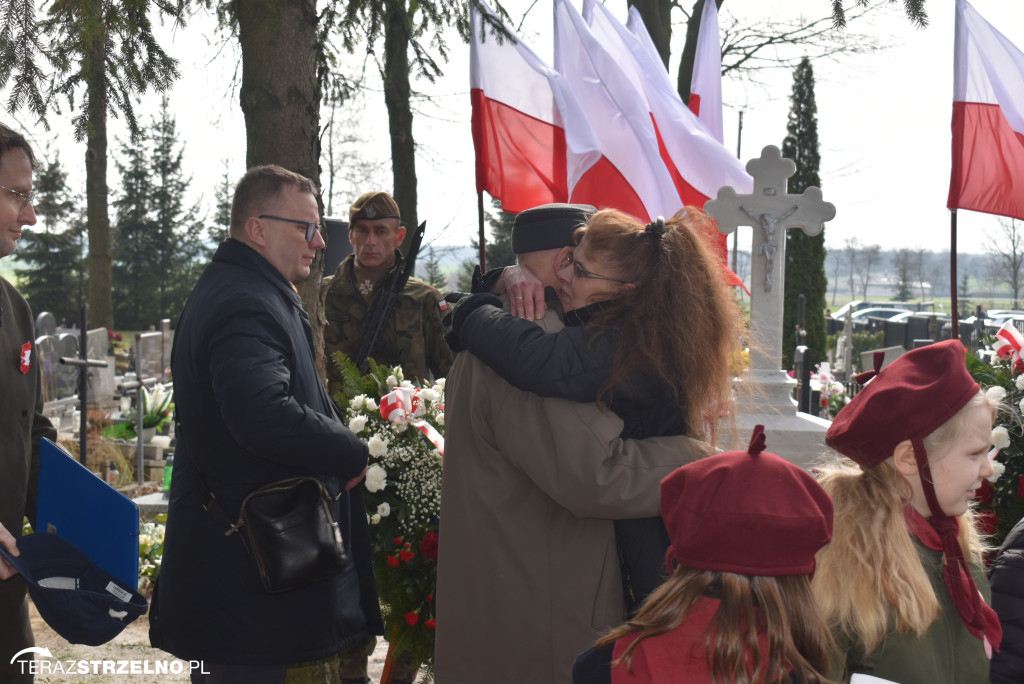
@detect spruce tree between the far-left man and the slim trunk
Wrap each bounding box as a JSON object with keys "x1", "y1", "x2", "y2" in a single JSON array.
[{"x1": 17, "y1": 155, "x2": 86, "y2": 325}]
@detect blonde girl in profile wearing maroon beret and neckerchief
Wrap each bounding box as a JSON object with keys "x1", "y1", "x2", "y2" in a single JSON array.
[{"x1": 813, "y1": 340, "x2": 1001, "y2": 684}]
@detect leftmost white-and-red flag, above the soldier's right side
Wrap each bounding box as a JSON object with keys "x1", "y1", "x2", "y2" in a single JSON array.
[{"x1": 470, "y1": 2, "x2": 603, "y2": 213}]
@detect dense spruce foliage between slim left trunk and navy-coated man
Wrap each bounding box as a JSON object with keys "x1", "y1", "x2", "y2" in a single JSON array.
[{"x1": 114, "y1": 99, "x2": 209, "y2": 330}]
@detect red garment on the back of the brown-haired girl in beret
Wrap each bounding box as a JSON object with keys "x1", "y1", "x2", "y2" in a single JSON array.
[{"x1": 611, "y1": 596, "x2": 768, "y2": 684}]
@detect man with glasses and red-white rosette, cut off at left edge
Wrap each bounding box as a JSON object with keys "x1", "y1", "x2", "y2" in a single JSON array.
[{"x1": 0, "y1": 124, "x2": 56, "y2": 682}]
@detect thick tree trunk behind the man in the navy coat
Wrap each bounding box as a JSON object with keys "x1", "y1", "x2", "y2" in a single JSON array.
[{"x1": 233, "y1": 0, "x2": 324, "y2": 373}]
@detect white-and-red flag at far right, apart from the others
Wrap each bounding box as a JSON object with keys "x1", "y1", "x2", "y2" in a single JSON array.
[{"x1": 946, "y1": 0, "x2": 1024, "y2": 220}]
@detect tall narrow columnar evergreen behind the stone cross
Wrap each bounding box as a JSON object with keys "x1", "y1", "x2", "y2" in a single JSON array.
[{"x1": 782, "y1": 57, "x2": 828, "y2": 368}]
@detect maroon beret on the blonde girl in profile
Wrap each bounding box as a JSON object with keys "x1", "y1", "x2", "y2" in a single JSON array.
[{"x1": 825, "y1": 340, "x2": 980, "y2": 469}]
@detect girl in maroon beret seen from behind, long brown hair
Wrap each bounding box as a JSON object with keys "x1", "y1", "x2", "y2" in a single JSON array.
[{"x1": 572, "y1": 425, "x2": 834, "y2": 684}]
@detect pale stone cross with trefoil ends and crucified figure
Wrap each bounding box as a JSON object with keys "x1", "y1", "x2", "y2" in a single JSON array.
[{"x1": 705, "y1": 145, "x2": 836, "y2": 371}]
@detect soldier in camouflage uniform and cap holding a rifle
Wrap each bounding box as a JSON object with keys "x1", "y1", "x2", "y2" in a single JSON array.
[{"x1": 322, "y1": 190, "x2": 452, "y2": 396}]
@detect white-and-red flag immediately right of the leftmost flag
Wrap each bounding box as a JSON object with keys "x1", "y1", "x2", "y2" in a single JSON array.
[{"x1": 555, "y1": 0, "x2": 683, "y2": 221}]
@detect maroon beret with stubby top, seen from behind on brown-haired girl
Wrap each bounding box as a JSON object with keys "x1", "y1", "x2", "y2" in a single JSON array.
[{"x1": 662, "y1": 425, "x2": 833, "y2": 576}]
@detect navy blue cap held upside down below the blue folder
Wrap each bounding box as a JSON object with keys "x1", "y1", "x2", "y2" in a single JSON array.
[{"x1": 0, "y1": 532, "x2": 150, "y2": 646}]
